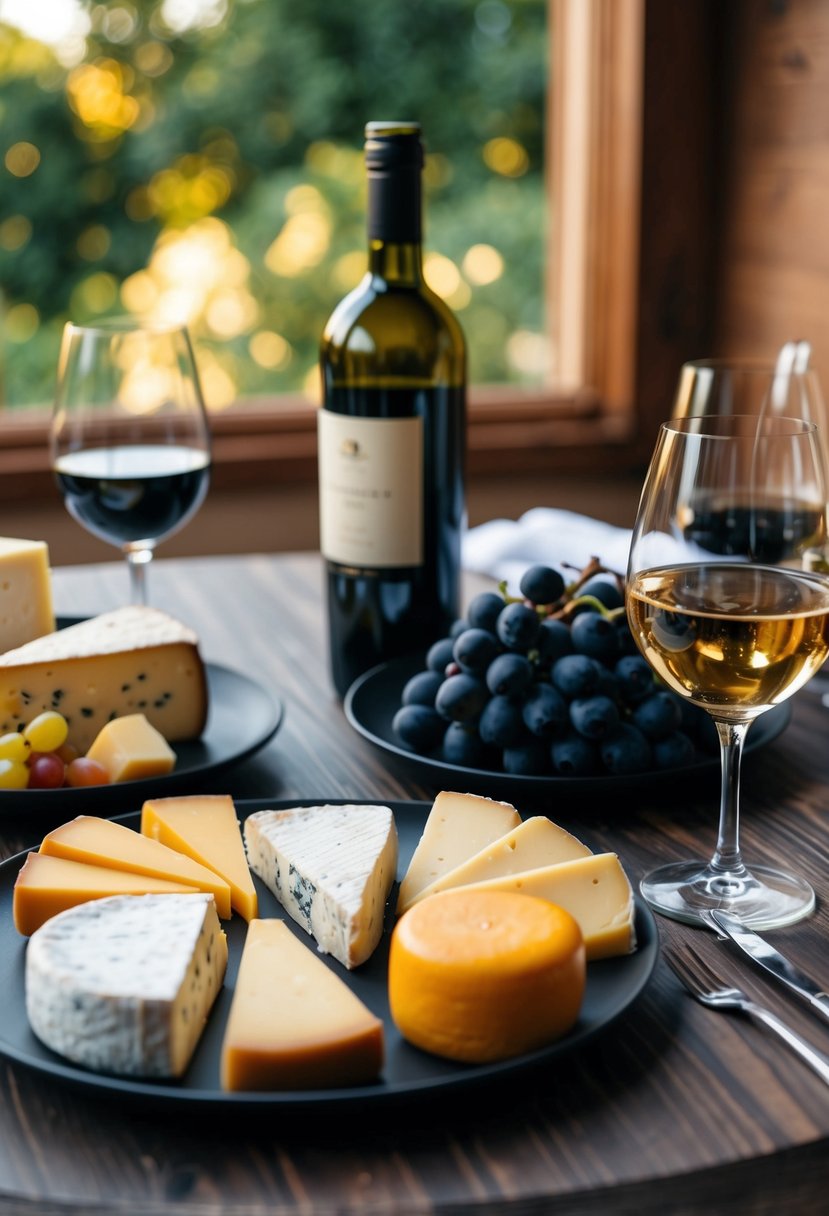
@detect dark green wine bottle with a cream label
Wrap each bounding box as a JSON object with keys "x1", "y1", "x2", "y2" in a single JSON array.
[{"x1": 318, "y1": 123, "x2": 466, "y2": 696}]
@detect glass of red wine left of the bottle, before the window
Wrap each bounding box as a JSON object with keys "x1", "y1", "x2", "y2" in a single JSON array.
[{"x1": 51, "y1": 321, "x2": 210, "y2": 604}]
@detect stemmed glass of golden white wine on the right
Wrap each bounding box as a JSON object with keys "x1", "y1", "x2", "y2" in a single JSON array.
[{"x1": 626, "y1": 413, "x2": 829, "y2": 929}]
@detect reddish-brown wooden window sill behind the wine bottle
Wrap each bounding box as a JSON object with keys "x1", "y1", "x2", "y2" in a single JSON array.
[{"x1": 0, "y1": 388, "x2": 637, "y2": 502}]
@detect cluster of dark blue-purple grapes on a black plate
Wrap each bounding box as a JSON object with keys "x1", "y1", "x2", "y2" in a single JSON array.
[{"x1": 393, "y1": 559, "x2": 717, "y2": 777}]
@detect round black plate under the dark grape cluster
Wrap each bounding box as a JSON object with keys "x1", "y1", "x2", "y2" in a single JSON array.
[{"x1": 343, "y1": 654, "x2": 791, "y2": 803}]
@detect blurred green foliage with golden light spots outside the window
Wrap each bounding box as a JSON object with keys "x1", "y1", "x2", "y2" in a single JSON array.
[{"x1": 0, "y1": 0, "x2": 547, "y2": 407}]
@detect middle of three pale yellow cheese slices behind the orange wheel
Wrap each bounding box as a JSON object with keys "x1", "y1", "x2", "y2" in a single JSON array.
[{"x1": 410, "y1": 815, "x2": 591, "y2": 907}]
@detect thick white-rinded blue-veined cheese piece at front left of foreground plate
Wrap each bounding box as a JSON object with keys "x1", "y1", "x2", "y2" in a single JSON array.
[{"x1": 26, "y1": 893, "x2": 227, "y2": 1076}]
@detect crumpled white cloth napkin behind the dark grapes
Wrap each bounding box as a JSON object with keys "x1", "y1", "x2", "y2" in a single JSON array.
[{"x1": 463, "y1": 507, "x2": 631, "y2": 593}]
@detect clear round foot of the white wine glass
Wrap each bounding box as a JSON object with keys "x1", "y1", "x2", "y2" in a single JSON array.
[{"x1": 639, "y1": 861, "x2": 814, "y2": 929}]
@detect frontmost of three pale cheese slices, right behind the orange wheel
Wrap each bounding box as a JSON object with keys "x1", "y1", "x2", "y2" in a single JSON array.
[{"x1": 459, "y1": 852, "x2": 636, "y2": 962}]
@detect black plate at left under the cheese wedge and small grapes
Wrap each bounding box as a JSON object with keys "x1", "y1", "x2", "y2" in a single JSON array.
[{"x1": 0, "y1": 663, "x2": 283, "y2": 818}]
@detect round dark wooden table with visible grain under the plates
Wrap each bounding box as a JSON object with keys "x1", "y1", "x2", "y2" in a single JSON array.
[{"x1": 0, "y1": 556, "x2": 829, "y2": 1216}]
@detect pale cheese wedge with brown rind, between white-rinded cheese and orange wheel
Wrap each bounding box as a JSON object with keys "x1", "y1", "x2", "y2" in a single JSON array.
[{"x1": 221, "y1": 921, "x2": 383, "y2": 1090}]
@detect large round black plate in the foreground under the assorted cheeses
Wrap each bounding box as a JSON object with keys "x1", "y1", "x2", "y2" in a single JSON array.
[{"x1": 0, "y1": 799, "x2": 659, "y2": 1113}]
